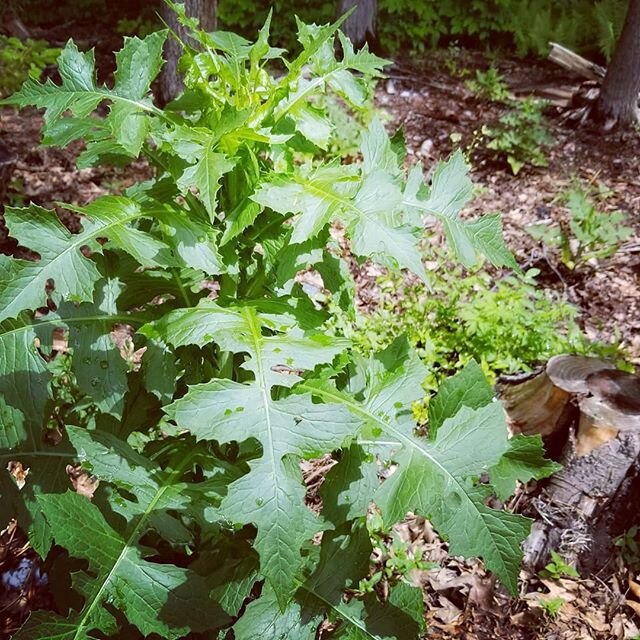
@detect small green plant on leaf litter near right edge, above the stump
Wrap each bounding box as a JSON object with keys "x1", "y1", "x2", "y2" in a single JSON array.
[{"x1": 527, "y1": 185, "x2": 633, "y2": 271}]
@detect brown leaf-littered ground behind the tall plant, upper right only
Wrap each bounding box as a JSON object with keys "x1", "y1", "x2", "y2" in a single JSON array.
[{"x1": 376, "y1": 52, "x2": 640, "y2": 364}]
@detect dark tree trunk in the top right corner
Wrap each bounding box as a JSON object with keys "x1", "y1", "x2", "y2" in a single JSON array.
[{"x1": 593, "y1": 0, "x2": 640, "y2": 131}]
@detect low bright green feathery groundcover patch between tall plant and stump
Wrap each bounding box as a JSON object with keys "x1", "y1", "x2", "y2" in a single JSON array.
[{"x1": 340, "y1": 250, "x2": 615, "y2": 394}]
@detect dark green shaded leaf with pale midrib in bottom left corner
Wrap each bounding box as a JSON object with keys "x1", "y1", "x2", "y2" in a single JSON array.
[{"x1": 14, "y1": 493, "x2": 225, "y2": 640}]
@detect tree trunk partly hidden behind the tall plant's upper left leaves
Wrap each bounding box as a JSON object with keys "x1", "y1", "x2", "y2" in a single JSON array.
[{"x1": 159, "y1": 0, "x2": 217, "y2": 104}]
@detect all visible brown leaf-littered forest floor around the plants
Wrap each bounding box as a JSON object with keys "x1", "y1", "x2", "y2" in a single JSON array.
[{"x1": 0, "y1": 36, "x2": 640, "y2": 640}]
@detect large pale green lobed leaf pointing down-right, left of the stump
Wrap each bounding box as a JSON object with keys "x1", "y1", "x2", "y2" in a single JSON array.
[{"x1": 376, "y1": 403, "x2": 531, "y2": 593}]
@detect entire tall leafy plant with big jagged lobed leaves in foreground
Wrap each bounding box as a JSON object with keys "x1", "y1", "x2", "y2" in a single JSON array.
[{"x1": 0, "y1": 5, "x2": 554, "y2": 640}]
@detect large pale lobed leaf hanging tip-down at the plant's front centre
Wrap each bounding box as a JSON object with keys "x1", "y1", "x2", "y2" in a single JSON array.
[{"x1": 160, "y1": 301, "x2": 356, "y2": 608}]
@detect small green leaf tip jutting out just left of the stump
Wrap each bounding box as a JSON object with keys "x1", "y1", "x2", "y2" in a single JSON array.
[{"x1": 489, "y1": 434, "x2": 562, "y2": 500}]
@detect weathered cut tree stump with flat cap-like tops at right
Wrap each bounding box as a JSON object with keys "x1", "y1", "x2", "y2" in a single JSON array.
[{"x1": 498, "y1": 356, "x2": 640, "y2": 571}]
